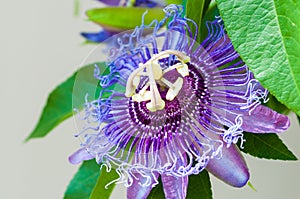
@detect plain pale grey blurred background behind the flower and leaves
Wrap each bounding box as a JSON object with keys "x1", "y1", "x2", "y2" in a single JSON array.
[{"x1": 0, "y1": 0, "x2": 300, "y2": 199}]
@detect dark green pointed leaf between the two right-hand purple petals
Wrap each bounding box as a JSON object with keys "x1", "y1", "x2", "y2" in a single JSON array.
[{"x1": 238, "y1": 132, "x2": 297, "y2": 160}]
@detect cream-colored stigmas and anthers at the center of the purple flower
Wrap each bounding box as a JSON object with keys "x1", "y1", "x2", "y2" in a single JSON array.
[{"x1": 125, "y1": 50, "x2": 190, "y2": 112}]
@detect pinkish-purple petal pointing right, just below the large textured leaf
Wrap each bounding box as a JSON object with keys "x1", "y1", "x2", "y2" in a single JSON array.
[{"x1": 242, "y1": 105, "x2": 290, "y2": 133}]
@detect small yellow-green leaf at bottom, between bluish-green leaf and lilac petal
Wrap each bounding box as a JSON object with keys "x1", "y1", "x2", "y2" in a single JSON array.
[{"x1": 90, "y1": 168, "x2": 119, "y2": 199}]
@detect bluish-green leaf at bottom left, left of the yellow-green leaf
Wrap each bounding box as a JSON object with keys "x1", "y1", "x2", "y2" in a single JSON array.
[{"x1": 64, "y1": 159, "x2": 100, "y2": 199}]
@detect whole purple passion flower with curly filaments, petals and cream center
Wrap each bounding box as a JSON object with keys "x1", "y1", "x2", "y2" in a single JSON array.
[{"x1": 70, "y1": 5, "x2": 289, "y2": 198}]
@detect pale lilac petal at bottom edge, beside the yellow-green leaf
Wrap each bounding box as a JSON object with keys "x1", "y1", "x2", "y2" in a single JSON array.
[{"x1": 127, "y1": 173, "x2": 159, "y2": 199}]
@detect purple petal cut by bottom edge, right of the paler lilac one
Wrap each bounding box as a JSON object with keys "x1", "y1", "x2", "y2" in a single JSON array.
[{"x1": 161, "y1": 174, "x2": 188, "y2": 199}]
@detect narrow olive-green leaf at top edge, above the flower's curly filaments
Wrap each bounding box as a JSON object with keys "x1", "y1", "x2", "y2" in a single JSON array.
[{"x1": 186, "y1": 0, "x2": 205, "y2": 43}]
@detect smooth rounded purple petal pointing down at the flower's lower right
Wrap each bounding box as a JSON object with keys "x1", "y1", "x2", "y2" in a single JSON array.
[{"x1": 206, "y1": 144, "x2": 249, "y2": 187}]
